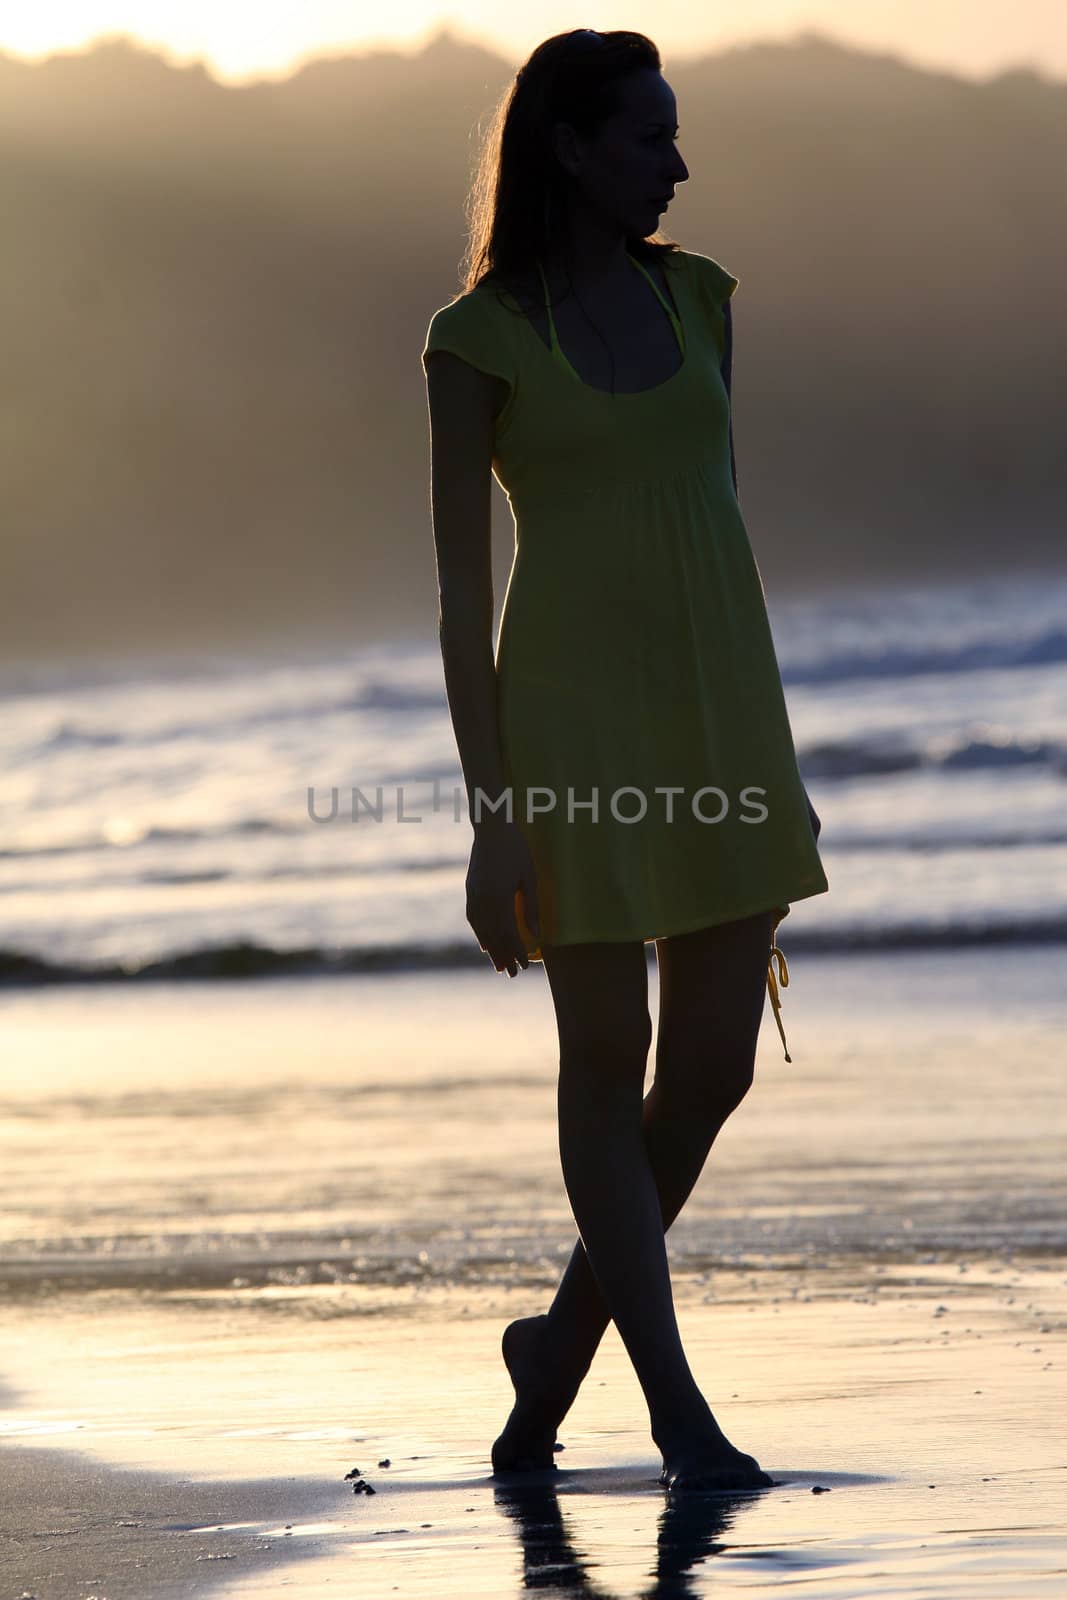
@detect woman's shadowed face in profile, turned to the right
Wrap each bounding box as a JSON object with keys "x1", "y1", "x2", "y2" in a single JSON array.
[{"x1": 557, "y1": 67, "x2": 689, "y2": 238}]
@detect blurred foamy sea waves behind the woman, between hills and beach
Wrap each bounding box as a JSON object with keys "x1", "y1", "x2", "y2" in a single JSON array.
[{"x1": 0, "y1": 578, "x2": 1067, "y2": 982}]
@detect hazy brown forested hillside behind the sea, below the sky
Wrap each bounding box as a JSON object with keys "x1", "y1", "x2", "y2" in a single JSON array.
[{"x1": 0, "y1": 32, "x2": 1067, "y2": 658}]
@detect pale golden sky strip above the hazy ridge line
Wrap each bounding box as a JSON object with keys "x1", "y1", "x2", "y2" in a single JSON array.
[{"x1": 0, "y1": 0, "x2": 1067, "y2": 82}]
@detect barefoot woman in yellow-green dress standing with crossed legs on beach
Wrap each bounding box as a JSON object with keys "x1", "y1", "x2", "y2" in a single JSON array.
[{"x1": 422, "y1": 29, "x2": 827, "y2": 1490}]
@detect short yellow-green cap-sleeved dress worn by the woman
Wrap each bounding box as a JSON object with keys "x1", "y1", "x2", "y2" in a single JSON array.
[{"x1": 422, "y1": 250, "x2": 829, "y2": 1059}]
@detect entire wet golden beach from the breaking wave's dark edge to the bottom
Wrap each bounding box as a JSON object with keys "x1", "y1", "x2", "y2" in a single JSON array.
[{"x1": 0, "y1": 950, "x2": 1067, "y2": 1600}]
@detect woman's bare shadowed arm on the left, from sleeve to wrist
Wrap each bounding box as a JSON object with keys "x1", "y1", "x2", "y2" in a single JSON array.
[{"x1": 426, "y1": 350, "x2": 506, "y2": 832}]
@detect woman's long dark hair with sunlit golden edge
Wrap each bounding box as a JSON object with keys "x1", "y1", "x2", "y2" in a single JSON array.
[{"x1": 461, "y1": 27, "x2": 678, "y2": 293}]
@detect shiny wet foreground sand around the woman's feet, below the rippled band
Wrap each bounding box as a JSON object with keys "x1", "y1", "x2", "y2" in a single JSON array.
[{"x1": 0, "y1": 1259, "x2": 1067, "y2": 1600}]
